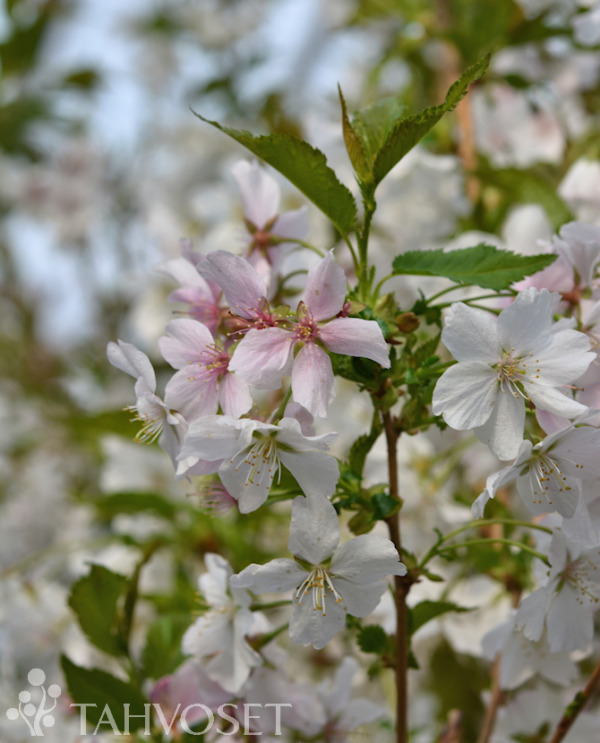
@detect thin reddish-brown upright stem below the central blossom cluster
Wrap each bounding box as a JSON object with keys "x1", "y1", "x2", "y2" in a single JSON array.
[{"x1": 382, "y1": 411, "x2": 411, "y2": 743}]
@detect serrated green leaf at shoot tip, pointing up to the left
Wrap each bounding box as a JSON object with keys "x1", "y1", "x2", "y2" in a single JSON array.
[{"x1": 196, "y1": 114, "x2": 356, "y2": 235}]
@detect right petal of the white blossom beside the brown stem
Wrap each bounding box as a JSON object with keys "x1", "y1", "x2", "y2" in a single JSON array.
[{"x1": 331, "y1": 534, "x2": 406, "y2": 583}]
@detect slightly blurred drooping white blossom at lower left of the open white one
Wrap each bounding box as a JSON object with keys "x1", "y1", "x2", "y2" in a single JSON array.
[{"x1": 182, "y1": 553, "x2": 268, "y2": 692}]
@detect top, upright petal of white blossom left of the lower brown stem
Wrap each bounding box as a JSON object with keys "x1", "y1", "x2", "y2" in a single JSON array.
[{"x1": 288, "y1": 495, "x2": 340, "y2": 565}]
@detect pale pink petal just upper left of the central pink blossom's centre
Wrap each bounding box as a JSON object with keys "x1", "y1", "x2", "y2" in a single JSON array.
[{"x1": 198, "y1": 250, "x2": 267, "y2": 318}]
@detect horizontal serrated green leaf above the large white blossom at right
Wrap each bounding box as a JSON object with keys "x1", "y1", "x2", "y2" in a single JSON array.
[{"x1": 393, "y1": 243, "x2": 556, "y2": 291}]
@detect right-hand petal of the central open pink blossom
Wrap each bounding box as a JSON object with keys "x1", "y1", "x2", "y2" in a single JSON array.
[{"x1": 320, "y1": 317, "x2": 390, "y2": 369}]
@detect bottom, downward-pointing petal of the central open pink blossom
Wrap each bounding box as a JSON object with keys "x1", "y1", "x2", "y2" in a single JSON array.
[{"x1": 292, "y1": 343, "x2": 335, "y2": 418}]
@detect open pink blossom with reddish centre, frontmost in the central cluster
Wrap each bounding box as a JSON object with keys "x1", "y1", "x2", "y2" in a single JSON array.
[{"x1": 229, "y1": 252, "x2": 390, "y2": 417}]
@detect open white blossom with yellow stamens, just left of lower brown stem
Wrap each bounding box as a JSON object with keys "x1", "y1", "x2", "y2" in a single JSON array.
[{"x1": 230, "y1": 496, "x2": 406, "y2": 650}]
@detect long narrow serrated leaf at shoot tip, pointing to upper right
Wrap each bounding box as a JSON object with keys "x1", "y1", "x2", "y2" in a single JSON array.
[{"x1": 373, "y1": 55, "x2": 490, "y2": 183}]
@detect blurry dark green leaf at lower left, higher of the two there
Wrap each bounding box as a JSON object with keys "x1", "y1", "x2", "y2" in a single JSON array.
[{"x1": 69, "y1": 565, "x2": 127, "y2": 656}]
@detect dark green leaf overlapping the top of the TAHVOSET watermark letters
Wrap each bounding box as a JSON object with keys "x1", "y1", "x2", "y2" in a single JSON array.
[{"x1": 60, "y1": 655, "x2": 146, "y2": 733}]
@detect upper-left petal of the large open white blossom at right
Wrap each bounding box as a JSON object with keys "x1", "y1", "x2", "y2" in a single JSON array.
[{"x1": 442, "y1": 302, "x2": 500, "y2": 364}]
